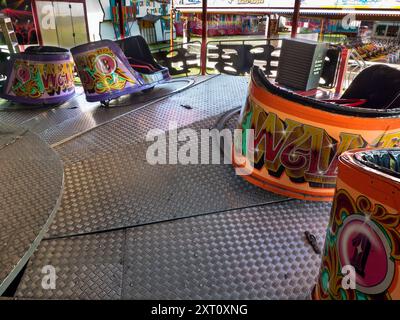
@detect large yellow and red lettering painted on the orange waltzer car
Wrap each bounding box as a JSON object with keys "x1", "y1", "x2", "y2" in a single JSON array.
[{"x1": 242, "y1": 100, "x2": 367, "y2": 188}]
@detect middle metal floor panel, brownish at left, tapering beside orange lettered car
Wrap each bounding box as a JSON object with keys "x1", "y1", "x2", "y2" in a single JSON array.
[{"x1": 47, "y1": 117, "x2": 285, "y2": 237}]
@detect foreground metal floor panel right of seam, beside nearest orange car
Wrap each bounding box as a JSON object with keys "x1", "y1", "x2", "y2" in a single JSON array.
[{"x1": 123, "y1": 201, "x2": 330, "y2": 299}]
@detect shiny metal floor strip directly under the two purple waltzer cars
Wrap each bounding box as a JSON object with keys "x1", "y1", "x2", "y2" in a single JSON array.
[{"x1": 0, "y1": 77, "x2": 206, "y2": 144}]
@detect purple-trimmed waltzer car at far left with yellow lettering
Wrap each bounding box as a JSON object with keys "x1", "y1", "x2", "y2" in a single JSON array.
[{"x1": 1, "y1": 47, "x2": 75, "y2": 105}]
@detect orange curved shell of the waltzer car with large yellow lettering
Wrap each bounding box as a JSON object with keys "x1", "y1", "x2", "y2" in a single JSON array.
[{"x1": 233, "y1": 67, "x2": 400, "y2": 201}]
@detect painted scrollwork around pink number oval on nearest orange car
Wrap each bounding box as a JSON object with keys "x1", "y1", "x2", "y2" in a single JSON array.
[{"x1": 314, "y1": 190, "x2": 400, "y2": 300}]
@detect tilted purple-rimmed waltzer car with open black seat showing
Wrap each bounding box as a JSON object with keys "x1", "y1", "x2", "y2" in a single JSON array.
[{"x1": 71, "y1": 37, "x2": 169, "y2": 104}]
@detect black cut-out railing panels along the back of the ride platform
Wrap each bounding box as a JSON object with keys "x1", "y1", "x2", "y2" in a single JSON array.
[{"x1": 152, "y1": 37, "x2": 366, "y2": 88}]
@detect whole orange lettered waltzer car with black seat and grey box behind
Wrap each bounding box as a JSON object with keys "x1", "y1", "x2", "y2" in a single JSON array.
[{"x1": 233, "y1": 40, "x2": 400, "y2": 201}]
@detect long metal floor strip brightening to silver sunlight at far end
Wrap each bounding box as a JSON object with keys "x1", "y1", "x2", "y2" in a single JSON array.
[{"x1": 56, "y1": 76, "x2": 248, "y2": 162}]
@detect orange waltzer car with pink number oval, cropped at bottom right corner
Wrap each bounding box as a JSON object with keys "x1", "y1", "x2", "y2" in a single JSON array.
[{"x1": 312, "y1": 149, "x2": 400, "y2": 300}]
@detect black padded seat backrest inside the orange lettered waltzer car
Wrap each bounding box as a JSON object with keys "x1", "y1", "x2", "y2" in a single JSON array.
[{"x1": 342, "y1": 64, "x2": 400, "y2": 109}]
